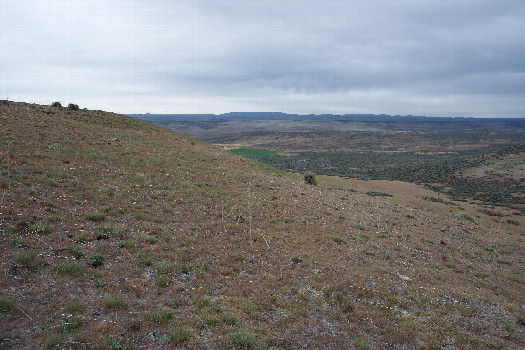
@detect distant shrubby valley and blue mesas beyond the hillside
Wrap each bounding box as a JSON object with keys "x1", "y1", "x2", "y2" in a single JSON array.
[{"x1": 134, "y1": 113, "x2": 525, "y2": 212}]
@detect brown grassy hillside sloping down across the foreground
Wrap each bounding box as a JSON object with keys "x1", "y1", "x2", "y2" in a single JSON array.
[{"x1": 0, "y1": 101, "x2": 525, "y2": 349}]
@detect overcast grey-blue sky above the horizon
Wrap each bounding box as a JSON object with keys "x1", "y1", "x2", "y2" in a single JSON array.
[{"x1": 0, "y1": 0, "x2": 525, "y2": 117}]
